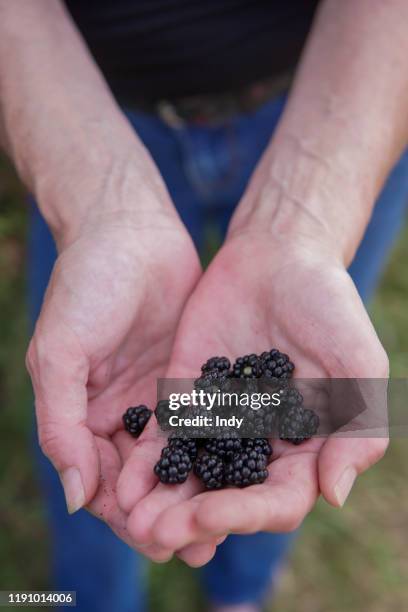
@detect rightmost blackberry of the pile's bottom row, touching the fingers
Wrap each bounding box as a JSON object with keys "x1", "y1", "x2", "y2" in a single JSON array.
[{"x1": 225, "y1": 447, "x2": 268, "y2": 487}]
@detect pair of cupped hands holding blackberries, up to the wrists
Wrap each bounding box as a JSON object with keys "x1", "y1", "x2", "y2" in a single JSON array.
[{"x1": 27, "y1": 147, "x2": 388, "y2": 566}]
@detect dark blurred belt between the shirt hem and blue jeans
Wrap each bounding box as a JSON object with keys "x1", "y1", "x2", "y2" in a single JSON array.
[{"x1": 134, "y1": 73, "x2": 293, "y2": 128}]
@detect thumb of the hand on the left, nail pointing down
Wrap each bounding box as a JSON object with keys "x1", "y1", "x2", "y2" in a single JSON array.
[{"x1": 27, "y1": 326, "x2": 99, "y2": 514}]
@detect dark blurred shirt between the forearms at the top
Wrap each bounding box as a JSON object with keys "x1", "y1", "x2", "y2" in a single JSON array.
[{"x1": 66, "y1": 0, "x2": 317, "y2": 103}]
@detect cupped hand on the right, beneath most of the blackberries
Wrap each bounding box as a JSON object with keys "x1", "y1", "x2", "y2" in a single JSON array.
[{"x1": 123, "y1": 231, "x2": 388, "y2": 563}]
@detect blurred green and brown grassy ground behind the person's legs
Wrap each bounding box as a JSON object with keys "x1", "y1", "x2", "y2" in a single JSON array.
[{"x1": 0, "y1": 160, "x2": 408, "y2": 612}]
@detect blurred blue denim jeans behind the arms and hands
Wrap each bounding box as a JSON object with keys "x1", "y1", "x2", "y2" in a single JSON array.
[{"x1": 28, "y1": 93, "x2": 408, "y2": 612}]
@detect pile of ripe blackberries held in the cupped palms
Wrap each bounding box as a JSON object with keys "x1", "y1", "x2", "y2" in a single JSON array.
[{"x1": 123, "y1": 349, "x2": 319, "y2": 489}]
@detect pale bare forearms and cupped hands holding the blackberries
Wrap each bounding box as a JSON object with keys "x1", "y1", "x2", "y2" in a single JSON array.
[{"x1": 0, "y1": 0, "x2": 408, "y2": 566}]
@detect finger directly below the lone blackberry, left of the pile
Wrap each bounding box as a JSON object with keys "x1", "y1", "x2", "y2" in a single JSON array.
[{"x1": 114, "y1": 417, "x2": 166, "y2": 514}]
